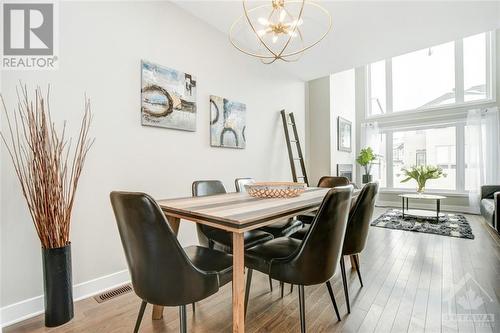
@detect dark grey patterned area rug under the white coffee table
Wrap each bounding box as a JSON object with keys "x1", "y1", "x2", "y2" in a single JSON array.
[{"x1": 371, "y1": 209, "x2": 474, "y2": 239}]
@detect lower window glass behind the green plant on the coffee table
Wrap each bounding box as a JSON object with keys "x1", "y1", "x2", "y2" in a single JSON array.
[{"x1": 392, "y1": 127, "x2": 457, "y2": 190}]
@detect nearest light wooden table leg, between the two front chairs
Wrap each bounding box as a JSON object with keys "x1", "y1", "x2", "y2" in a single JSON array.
[{"x1": 233, "y1": 232, "x2": 245, "y2": 333}]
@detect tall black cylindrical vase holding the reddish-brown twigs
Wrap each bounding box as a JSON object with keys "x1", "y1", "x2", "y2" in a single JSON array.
[{"x1": 42, "y1": 244, "x2": 73, "y2": 327}]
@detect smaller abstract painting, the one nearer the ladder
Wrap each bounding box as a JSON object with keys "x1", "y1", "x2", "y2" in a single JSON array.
[{"x1": 210, "y1": 95, "x2": 247, "y2": 149}]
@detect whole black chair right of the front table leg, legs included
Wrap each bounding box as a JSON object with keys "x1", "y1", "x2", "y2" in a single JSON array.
[{"x1": 245, "y1": 186, "x2": 352, "y2": 333}]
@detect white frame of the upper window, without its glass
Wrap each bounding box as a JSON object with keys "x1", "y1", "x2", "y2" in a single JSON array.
[{"x1": 365, "y1": 31, "x2": 496, "y2": 120}]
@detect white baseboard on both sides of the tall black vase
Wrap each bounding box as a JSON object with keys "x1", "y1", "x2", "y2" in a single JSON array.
[{"x1": 0, "y1": 269, "x2": 130, "y2": 327}]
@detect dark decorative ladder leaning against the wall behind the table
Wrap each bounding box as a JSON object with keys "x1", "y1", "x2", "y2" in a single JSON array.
[{"x1": 281, "y1": 110, "x2": 309, "y2": 186}]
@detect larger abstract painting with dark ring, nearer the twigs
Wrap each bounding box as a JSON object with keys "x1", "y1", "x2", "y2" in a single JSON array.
[{"x1": 141, "y1": 61, "x2": 196, "y2": 131}]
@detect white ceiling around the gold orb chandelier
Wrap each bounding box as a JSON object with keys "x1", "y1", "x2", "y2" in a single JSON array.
[{"x1": 175, "y1": 0, "x2": 500, "y2": 80}]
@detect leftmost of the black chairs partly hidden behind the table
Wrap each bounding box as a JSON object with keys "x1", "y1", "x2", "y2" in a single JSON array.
[{"x1": 192, "y1": 180, "x2": 273, "y2": 253}]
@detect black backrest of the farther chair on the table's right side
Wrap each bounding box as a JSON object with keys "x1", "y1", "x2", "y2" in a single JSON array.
[{"x1": 342, "y1": 183, "x2": 378, "y2": 255}]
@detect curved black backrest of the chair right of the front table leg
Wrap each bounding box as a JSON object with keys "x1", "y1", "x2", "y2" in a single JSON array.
[{"x1": 271, "y1": 186, "x2": 352, "y2": 285}]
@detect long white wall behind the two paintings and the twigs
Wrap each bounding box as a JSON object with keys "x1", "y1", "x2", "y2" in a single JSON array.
[{"x1": 0, "y1": 2, "x2": 304, "y2": 324}]
